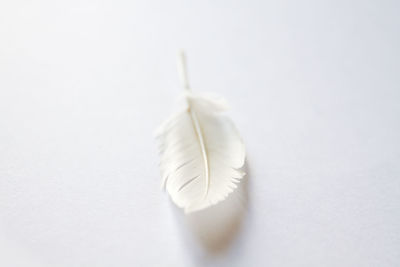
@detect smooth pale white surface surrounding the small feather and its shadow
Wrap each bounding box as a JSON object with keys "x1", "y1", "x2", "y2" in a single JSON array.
[{"x1": 0, "y1": 0, "x2": 400, "y2": 267}]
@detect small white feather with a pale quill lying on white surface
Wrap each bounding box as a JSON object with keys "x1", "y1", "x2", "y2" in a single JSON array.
[{"x1": 156, "y1": 54, "x2": 245, "y2": 213}]
